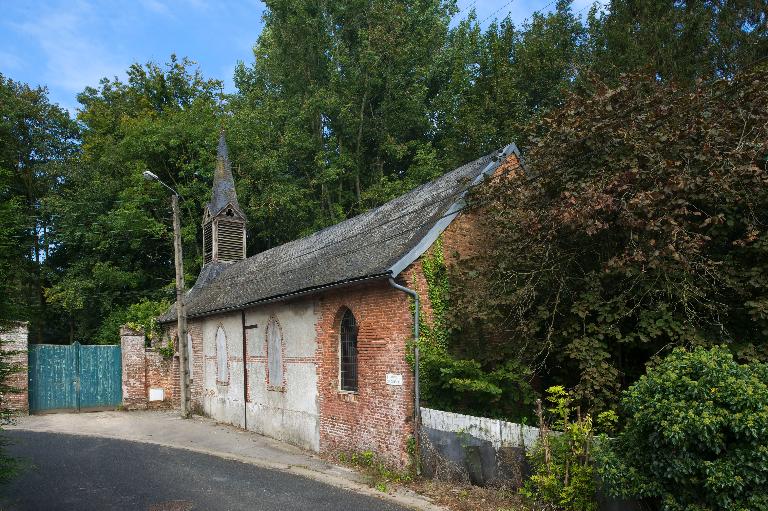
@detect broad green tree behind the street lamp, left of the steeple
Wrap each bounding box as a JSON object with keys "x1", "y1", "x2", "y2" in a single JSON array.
[{"x1": 47, "y1": 56, "x2": 221, "y2": 342}]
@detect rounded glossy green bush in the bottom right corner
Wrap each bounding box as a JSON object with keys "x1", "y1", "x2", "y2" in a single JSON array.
[{"x1": 600, "y1": 347, "x2": 768, "y2": 511}]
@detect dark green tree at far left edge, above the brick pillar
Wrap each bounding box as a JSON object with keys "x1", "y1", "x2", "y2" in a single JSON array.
[{"x1": 0, "y1": 75, "x2": 77, "y2": 342}]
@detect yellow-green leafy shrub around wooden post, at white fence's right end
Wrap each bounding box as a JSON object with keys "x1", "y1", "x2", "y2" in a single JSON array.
[{"x1": 522, "y1": 386, "x2": 616, "y2": 511}]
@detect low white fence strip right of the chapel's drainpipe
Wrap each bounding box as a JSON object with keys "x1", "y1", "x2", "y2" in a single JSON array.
[{"x1": 421, "y1": 408, "x2": 539, "y2": 449}]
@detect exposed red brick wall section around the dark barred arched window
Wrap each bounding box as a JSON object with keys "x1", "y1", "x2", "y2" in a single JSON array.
[{"x1": 317, "y1": 281, "x2": 413, "y2": 467}]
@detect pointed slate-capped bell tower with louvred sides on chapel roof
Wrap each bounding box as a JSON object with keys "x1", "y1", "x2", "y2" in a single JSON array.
[{"x1": 203, "y1": 129, "x2": 246, "y2": 266}]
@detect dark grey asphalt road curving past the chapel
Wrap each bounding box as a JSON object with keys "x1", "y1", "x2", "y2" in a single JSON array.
[{"x1": 0, "y1": 430, "x2": 412, "y2": 511}]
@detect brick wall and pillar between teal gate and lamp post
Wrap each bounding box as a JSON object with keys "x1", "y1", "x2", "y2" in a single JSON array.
[{"x1": 120, "y1": 326, "x2": 179, "y2": 410}]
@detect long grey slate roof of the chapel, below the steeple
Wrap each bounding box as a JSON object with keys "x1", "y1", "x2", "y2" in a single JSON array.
[{"x1": 159, "y1": 144, "x2": 519, "y2": 322}]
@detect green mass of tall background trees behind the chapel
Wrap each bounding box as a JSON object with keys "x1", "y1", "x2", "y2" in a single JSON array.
[{"x1": 0, "y1": 0, "x2": 768, "y2": 360}]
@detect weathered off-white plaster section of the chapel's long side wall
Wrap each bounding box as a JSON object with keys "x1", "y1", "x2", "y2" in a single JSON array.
[{"x1": 202, "y1": 299, "x2": 320, "y2": 451}]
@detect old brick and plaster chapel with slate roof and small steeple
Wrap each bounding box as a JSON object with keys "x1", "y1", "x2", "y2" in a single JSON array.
[{"x1": 160, "y1": 133, "x2": 520, "y2": 466}]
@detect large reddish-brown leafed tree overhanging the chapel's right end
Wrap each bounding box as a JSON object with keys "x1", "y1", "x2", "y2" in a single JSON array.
[{"x1": 454, "y1": 67, "x2": 768, "y2": 409}]
